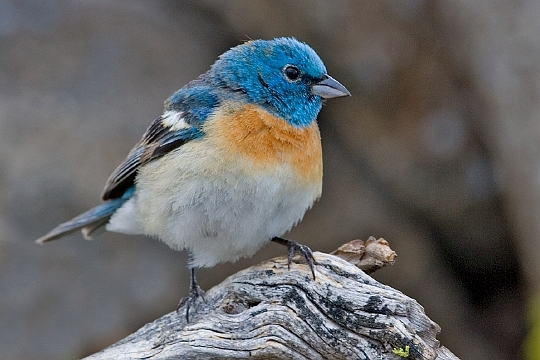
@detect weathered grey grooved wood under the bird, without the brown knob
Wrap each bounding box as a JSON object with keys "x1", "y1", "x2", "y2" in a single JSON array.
[{"x1": 86, "y1": 239, "x2": 457, "y2": 360}]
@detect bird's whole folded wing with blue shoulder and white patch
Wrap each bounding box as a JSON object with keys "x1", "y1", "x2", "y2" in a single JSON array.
[{"x1": 101, "y1": 86, "x2": 218, "y2": 200}]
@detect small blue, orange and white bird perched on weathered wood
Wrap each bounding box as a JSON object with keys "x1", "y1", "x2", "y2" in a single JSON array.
[{"x1": 36, "y1": 37, "x2": 351, "y2": 322}]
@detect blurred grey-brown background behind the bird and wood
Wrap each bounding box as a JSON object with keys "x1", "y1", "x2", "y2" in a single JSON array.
[{"x1": 0, "y1": 0, "x2": 540, "y2": 360}]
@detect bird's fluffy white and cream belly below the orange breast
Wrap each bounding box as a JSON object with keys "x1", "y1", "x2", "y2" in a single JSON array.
[{"x1": 107, "y1": 144, "x2": 321, "y2": 267}]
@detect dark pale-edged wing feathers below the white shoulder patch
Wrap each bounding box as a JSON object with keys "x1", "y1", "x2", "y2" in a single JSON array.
[{"x1": 101, "y1": 116, "x2": 202, "y2": 200}]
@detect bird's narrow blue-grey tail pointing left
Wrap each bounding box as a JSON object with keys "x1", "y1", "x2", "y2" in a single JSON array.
[{"x1": 36, "y1": 196, "x2": 129, "y2": 244}]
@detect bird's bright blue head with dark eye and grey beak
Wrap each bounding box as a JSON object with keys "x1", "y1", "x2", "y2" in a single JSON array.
[{"x1": 210, "y1": 38, "x2": 350, "y2": 127}]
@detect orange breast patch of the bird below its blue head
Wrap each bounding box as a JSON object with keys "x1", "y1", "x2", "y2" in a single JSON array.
[{"x1": 205, "y1": 105, "x2": 322, "y2": 182}]
